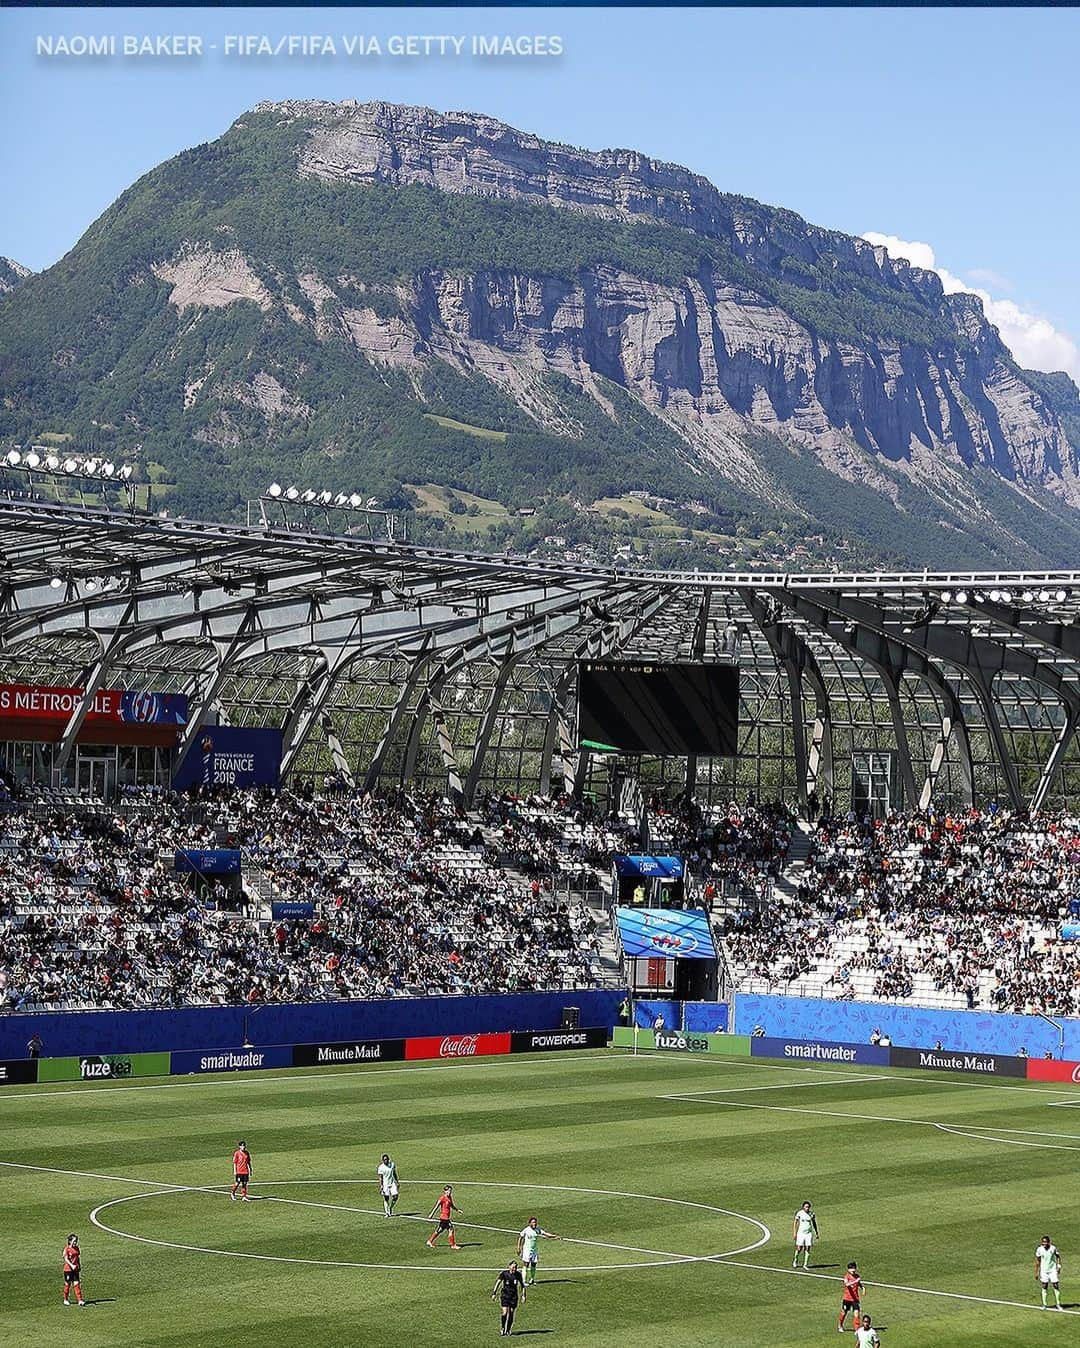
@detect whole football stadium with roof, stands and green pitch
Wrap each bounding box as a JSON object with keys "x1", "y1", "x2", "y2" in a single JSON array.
[{"x1": 0, "y1": 489, "x2": 1080, "y2": 1345}]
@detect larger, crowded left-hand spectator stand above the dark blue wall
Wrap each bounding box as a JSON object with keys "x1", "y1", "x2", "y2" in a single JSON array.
[{"x1": 0, "y1": 791, "x2": 600, "y2": 1011}]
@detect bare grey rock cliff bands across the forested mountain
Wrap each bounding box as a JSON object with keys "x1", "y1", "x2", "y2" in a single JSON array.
[{"x1": 240, "y1": 102, "x2": 1080, "y2": 504}]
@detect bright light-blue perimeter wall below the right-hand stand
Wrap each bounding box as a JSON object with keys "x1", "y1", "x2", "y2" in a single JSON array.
[{"x1": 735, "y1": 992, "x2": 1080, "y2": 1061}]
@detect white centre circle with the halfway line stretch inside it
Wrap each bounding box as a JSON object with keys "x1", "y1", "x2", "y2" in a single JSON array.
[{"x1": 88, "y1": 1167, "x2": 773, "y2": 1273}]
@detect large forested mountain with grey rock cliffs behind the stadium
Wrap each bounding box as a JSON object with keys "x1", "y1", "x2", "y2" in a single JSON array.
[{"x1": 0, "y1": 102, "x2": 1080, "y2": 566}]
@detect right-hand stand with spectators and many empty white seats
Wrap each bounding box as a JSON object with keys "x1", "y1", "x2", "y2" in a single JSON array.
[{"x1": 720, "y1": 807, "x2": 1080, "y2": 1015}]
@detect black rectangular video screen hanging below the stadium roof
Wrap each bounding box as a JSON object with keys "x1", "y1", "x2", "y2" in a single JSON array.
[{"x1": 577, "y1": 661, "x2": 739, "y2": 758}]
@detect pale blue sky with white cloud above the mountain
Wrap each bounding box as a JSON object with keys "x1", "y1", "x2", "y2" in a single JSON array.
[{"x1": 0, "y1": 8, "x2": 1080, "y2": 377}]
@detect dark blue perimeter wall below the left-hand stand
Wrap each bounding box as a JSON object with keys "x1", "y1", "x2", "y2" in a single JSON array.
[{"x1": 0, "y1": 989, "x2": 623, "y2": 1058}]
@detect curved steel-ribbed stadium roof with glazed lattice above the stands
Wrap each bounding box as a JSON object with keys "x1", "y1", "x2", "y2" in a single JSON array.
[{"x1": 0, "y1": 497, "x2": 1080, "y2": 805}]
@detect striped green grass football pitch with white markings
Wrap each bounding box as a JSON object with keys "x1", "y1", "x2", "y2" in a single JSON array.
[{"x1": 0, "y1": 1051, "x2": 1080, "y2": 1348}]
